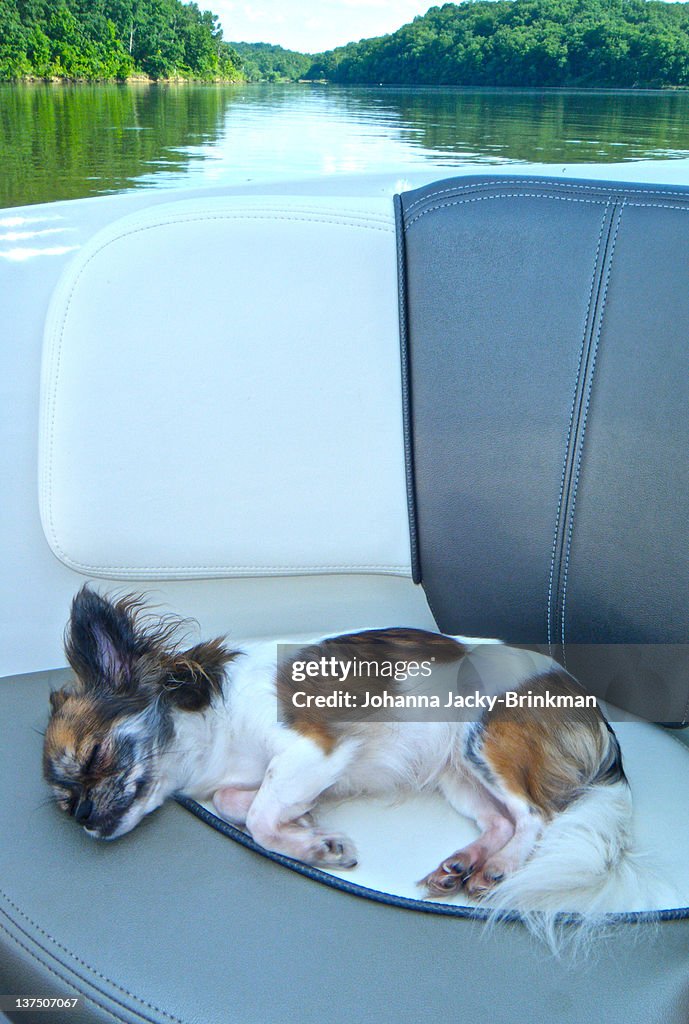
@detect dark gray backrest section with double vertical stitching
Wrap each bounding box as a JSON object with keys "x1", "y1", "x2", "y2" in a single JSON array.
[{"x1": 401, "y1": 177, "x2": 689, "y2": 722}]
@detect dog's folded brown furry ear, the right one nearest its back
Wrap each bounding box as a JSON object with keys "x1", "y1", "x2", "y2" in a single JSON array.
[{"x1": 163, "y1": 637, "x2": 236, "y2": 711}]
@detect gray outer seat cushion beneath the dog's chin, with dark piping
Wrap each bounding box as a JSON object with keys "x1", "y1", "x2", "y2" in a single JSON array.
[{"x1": 0, "y1": 673, "x2": 689, "y2": 1024}]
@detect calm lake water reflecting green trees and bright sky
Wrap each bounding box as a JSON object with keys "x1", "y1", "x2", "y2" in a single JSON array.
[{"x1": 0, "y1": 84, "x2": 689, "y2": 207}]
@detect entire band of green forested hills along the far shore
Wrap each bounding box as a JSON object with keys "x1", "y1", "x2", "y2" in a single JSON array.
[{"x1": 0, "y1": 0, "x2": 689, "y2": 87}]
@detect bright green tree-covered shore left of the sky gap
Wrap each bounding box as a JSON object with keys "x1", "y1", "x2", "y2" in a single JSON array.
[{"x1": 0, "y1": 0, "x2": 242, "y2": 80}]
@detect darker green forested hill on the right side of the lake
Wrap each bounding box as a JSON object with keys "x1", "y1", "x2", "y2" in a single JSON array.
[{"x1": 306, "y1": 0, "x2": 689, "y2": 87}]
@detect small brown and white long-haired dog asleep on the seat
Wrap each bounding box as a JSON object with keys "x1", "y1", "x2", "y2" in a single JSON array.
[{"x1": 44, "y1": 587, "x2": 651, "y2": 946}]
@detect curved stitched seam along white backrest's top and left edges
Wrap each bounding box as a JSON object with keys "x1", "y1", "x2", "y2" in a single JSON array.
[{"x1": 41, "y1": 211, "x2": 394, "y2": 565}]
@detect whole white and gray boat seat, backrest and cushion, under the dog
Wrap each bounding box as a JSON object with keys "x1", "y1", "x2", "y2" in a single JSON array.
[{"x1": 0, "y1": 175, "x2": 689, "y2": 1024}]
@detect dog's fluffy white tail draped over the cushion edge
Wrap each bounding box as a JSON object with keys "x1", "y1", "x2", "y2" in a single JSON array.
[{"x1": 475, "y1": 776, "x2": 677, "y2": 951}]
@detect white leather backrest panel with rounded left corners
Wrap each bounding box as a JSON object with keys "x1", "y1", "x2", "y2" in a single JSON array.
[{"x1": 39, "y1": 197, "x2": 410, "y2": 579}]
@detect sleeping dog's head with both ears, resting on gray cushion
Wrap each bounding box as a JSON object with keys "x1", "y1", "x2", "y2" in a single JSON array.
[{"x1": 43, "y1": 587, "x2": 234, "y2": 839}]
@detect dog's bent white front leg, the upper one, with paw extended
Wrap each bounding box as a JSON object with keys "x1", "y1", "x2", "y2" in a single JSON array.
[{"x1": 247, "y1": 736, "x2": 356, "y2": 867}]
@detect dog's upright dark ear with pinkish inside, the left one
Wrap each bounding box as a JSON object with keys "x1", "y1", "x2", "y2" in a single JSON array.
[{"x1": 64, "y1": 585, "x2": 152, "y2": 690}]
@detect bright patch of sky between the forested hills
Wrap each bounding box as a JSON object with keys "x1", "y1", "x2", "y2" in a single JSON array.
[{"x1": 210, "y1": 0, "x2": 442, "y2": 53}]
